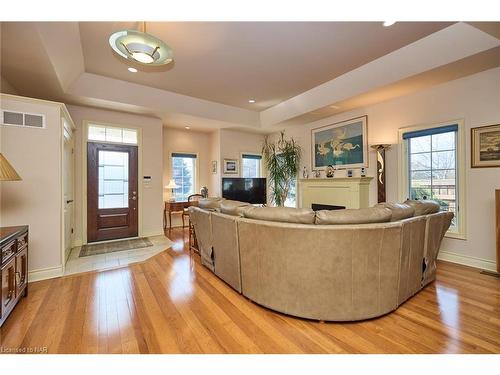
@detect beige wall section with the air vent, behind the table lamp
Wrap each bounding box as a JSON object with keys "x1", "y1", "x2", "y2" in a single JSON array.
[{"x1": 0, "y1": 96, "x2": 62, "y2": 277}]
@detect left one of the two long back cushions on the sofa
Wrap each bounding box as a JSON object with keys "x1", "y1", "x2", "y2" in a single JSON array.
[{"x1": 243, "y1": 207, "x2": 314, "y2": 224}]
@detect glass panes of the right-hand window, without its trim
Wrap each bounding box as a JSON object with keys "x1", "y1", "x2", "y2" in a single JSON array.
[{"x1": 408, "y1": 131, "x2": 458, "y2": 227}]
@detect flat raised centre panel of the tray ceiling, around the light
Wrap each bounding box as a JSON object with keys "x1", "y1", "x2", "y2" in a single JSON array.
[{"x1": 80, "y1": 22, "x2": 450, "y2": 110}]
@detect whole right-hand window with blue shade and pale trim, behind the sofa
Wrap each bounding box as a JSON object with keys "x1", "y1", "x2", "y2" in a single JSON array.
[{"x1": 400, "y1": 123, "x2": 464, "y2": 233}]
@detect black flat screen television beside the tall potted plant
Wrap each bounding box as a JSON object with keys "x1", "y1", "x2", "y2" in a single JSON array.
[{"x1": 222, "y1": 177, "x2": 267, "y2": 204}]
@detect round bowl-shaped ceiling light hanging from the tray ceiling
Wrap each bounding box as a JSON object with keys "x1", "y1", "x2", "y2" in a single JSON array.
[{"x1": 109, "y1": 22, "x2": 173, "y2": 66}]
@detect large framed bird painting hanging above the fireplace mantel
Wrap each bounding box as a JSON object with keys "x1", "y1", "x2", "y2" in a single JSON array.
[{"x1": 311, "y1": 116, "x2": 368, "y2": 170}]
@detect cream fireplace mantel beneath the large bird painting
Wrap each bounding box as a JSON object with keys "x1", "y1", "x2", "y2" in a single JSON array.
[{"x1": 298, "y1": 177, "x2": 373, "y2": 208}]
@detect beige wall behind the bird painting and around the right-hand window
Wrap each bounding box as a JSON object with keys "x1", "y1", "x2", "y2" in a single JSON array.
[{"x1": 272, "y1": 68, "x2": 500, "y2": 268}]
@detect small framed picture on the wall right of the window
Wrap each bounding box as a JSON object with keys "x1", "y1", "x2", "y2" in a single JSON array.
[{"x1": 471, "y1": 124, "x2": 500, "y2": 168}]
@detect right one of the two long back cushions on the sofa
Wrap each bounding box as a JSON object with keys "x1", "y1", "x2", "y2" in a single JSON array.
[{"x1": 316, "y1": 207, "x2": 392, "y2": 225}]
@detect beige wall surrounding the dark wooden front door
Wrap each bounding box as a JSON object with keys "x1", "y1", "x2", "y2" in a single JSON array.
[{"x1": 68, "y1": 105, "x2": 163, "y2": 244}]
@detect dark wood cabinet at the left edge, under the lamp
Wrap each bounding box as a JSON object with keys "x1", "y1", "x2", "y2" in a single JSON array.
[{"x1": 0, "y1": 226, "x2": 28, "y2": 326}]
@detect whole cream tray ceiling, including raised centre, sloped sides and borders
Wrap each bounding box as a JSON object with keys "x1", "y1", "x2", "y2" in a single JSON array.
[{"x1": 0, "y1": 22, "x2": 500, "y2": 132}]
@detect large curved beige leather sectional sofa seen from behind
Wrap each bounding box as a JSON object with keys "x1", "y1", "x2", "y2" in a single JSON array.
[{"x1": 190, "y1": 199, "x2": 453, "y2": 321}]
